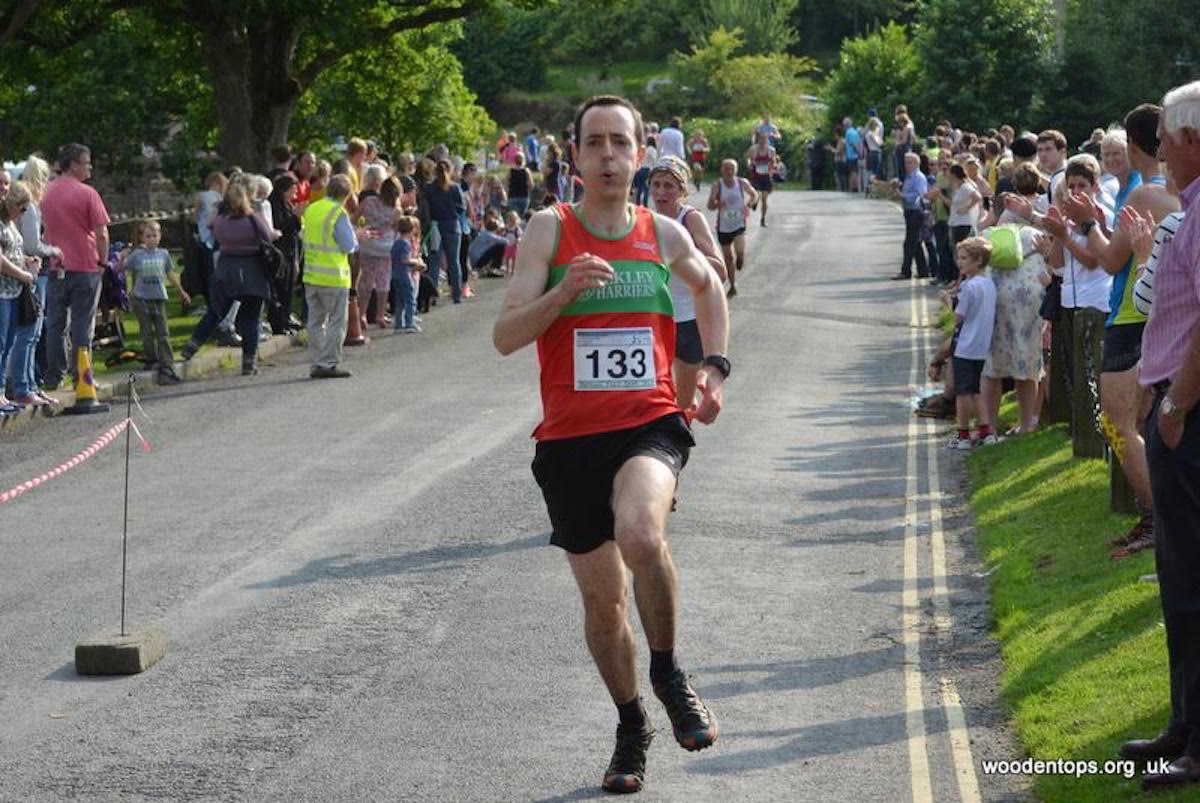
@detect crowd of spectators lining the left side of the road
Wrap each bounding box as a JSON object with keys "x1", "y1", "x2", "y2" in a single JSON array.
[{"x1": 0, "y1": 115, "x2": 785, "y2": 417}]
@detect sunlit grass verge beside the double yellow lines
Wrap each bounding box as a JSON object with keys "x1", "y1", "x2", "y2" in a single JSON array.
[{"x1": 967, "y1": 426, "x2": 1180, "y2": 803}]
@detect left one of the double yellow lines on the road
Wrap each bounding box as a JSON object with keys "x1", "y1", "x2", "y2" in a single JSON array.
[{"x1": 900, "y1": 286, "x2": 934, "y2": 803}]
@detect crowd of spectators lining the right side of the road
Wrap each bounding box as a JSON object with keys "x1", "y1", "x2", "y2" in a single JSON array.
[{"x1": 888, "y1": 82, "x2": 1200, "y2": 787}]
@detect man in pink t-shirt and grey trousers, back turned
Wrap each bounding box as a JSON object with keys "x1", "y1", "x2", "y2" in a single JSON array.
[{"x1": 42, "y1": 143, "x2": 108, "y2": 390}]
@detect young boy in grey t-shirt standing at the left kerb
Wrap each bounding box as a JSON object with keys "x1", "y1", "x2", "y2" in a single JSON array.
[{"x1": 124, "y1": 221, "x2": 191, "y2": 385}]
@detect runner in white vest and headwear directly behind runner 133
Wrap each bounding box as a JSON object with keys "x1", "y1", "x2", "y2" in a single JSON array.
[{"x1": 650, "y1": 156, "x2": 725, "y2": 409}]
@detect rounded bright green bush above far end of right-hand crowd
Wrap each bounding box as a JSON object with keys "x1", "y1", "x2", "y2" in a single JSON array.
[{"x1": 821, "y1": 23, "x2": 920, "y2": 128}]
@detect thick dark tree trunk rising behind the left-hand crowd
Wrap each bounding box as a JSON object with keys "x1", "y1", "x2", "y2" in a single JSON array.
[{"x1": 199, "y1": 14, "x2": 301, "y2": 173}]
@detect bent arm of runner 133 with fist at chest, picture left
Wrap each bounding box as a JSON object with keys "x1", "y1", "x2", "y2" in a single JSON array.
[{"x1": 492, "y1": 209, "x2": 614, "y2": 355}]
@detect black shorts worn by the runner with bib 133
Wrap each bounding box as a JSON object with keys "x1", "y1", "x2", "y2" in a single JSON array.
[{"x1": 533, "y1": 413, "x2": 696, "y2": 555}]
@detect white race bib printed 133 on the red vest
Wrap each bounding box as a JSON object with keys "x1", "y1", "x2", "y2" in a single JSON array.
[{"x1": 575, "y1": 326, "x2": 658, "y2": 390}]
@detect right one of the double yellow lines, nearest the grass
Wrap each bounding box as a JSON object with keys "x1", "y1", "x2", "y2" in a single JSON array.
[{"x1": 911, "y1": 293, "x2": 982, "y2": 803}]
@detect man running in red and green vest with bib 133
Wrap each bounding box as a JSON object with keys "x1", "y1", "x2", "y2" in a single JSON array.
[{"x1": 492, "y1": 96, "x2": 730, "y2": 792}]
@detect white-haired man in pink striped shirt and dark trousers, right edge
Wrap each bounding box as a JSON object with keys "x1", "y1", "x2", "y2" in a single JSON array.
[{"x1": 1121, "y1": 80, "x2": 1200, "y2": 789}]
